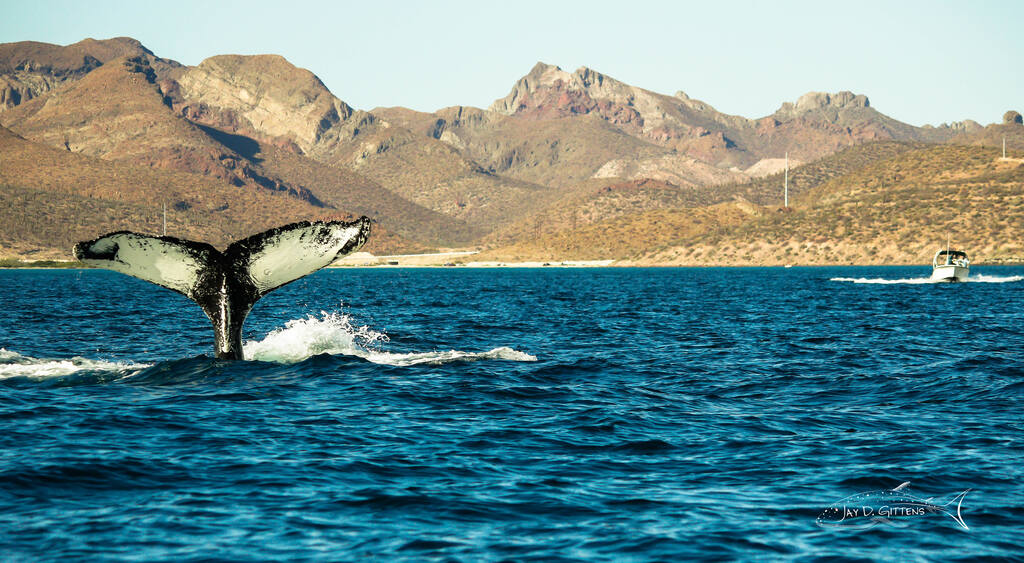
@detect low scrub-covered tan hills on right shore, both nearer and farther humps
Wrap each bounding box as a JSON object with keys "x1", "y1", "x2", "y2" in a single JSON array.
[{"x1": 475, "y1": 143, "x2": 1024, "y2": 265}]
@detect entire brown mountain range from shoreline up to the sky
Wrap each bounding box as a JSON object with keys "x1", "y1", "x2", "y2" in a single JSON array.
[{"x1": 0, "y1": 38, "x2": 1024, "y2": 264}]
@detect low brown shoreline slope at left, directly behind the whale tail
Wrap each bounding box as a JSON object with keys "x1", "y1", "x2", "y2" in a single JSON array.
[{"x1": 0, "y1": 128, "x2": 422, "y2": 258}]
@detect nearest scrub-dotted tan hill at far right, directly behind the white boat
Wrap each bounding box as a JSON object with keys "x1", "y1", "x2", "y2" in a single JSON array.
[{"x1": 637, "y1": 145, "x2": 1024, "y2": 265}]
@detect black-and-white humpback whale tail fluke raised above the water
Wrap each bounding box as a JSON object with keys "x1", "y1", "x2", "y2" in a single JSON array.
[{"x1": 75, "y1": 217, "x2": 370, "y2": 359}]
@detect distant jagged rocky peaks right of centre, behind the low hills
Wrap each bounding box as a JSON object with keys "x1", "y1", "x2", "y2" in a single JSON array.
[{"x1": 374, "y1": 63, "x2": 956, "y2": 207}]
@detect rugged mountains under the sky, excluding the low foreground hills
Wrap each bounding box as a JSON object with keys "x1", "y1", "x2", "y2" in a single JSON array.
[{"x1": 0, "y1": 38, "x2": 1019, "y2": 264}]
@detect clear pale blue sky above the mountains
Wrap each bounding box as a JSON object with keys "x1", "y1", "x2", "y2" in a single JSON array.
[{"x1": 0, "y1": 0, "x2": 1024, "y2": 125}]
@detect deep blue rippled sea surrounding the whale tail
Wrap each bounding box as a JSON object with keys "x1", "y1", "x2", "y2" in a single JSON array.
[{"x1": 0, "y1": 266, "x2": 1024, "y2": 562}]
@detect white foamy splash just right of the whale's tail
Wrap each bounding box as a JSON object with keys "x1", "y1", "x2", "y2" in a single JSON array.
[{"x1": 243, "y1": 311, "x2": 537, "y2": 366}]
